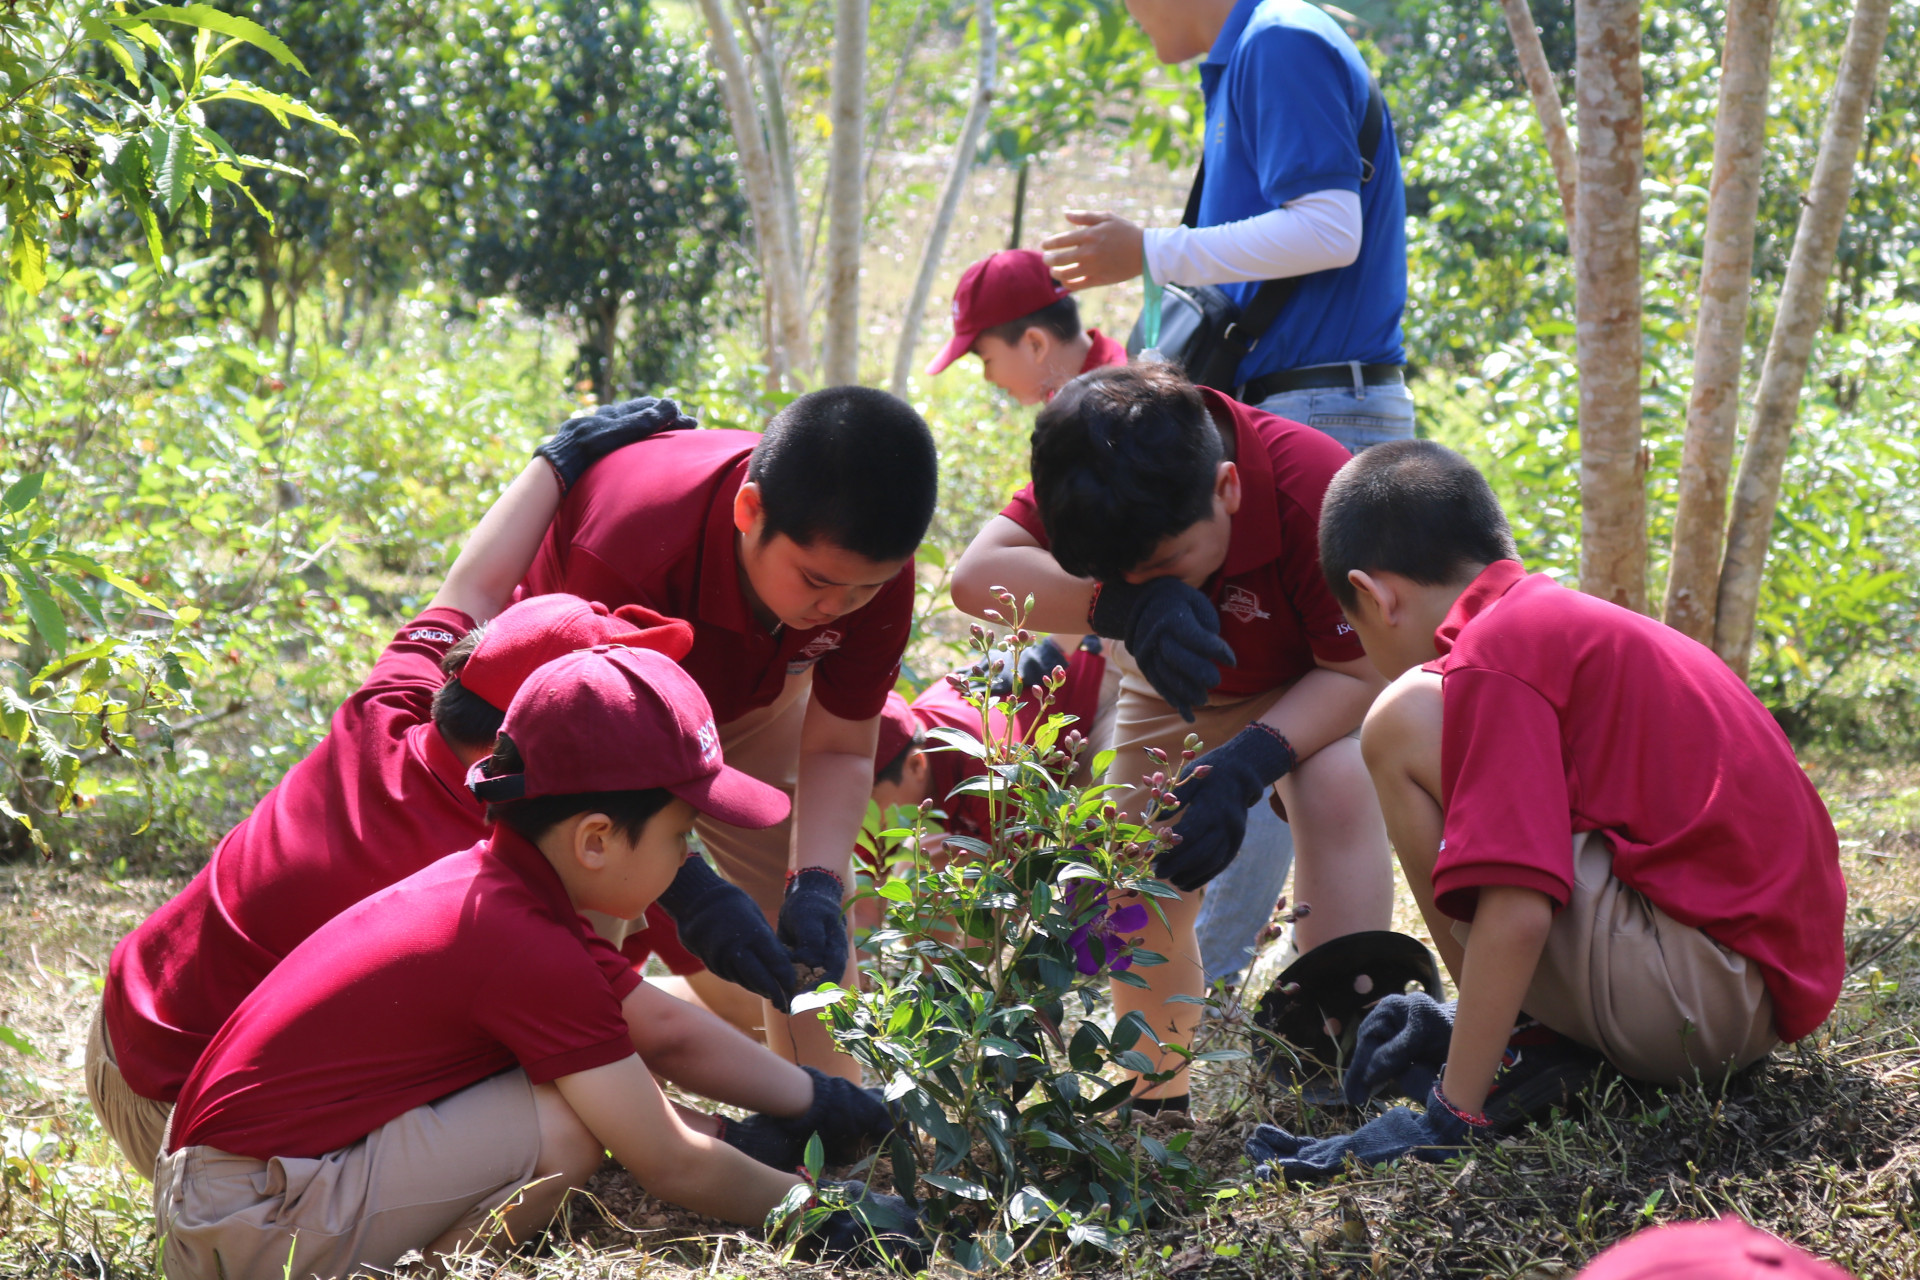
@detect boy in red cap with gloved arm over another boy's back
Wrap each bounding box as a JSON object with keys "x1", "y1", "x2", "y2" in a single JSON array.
[{"x1": 86, "y1": 401, "x2": 872, "y2": 1176}]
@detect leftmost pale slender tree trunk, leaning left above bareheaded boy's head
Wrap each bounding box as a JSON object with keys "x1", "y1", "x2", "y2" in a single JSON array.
[{"x1": 701, "y1": 0, "x2": 812, "y2": 390}]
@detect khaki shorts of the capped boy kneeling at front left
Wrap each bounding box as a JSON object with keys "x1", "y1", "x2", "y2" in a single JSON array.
[{"x1": 154, "y1": 1067, "x2": 540, "y2": 1280}]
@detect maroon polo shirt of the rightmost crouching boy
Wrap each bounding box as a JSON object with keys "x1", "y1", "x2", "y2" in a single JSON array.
[{"x1": 1427, "y1": 560, "x2": 1847, "y2": 1040}]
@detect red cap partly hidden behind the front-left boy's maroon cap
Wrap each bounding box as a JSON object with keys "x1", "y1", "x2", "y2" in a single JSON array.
[{"x1": 459, "y1": 593, "x2": 693, "y2": 710}]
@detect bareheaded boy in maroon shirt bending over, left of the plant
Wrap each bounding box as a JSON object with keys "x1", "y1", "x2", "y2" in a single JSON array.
[{"x1": 524, "y1": 388, "x2": 939, "y2": 1079}]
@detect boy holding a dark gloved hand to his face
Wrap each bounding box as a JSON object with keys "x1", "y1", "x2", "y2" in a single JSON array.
[{"x1": 954, "y1": 363, "x2": 1394, "y2": 1105}]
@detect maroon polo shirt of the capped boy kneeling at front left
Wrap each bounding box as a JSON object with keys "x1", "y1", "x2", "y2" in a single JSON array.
[{"x1": 169, "y1": 827, "x2": 639, "y2": 1159}]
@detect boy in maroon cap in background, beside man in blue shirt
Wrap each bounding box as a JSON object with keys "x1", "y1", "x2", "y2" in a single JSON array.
[{"x1": 927, "y1": 249, "x2": 1127, "y2": 405}]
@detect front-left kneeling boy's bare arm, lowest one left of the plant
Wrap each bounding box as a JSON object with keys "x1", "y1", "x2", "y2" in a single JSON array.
[{"x1": 553, "y1": 1055, "x2": 799, "y2": 1226}]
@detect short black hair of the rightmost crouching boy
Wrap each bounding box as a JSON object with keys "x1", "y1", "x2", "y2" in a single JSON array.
[{"x1": 1319, "y1": 439, "x2": 1521, "y2": 608}]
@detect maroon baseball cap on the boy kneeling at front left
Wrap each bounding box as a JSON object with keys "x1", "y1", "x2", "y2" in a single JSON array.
[{"x1": 467, "y1": 645, "x2": 791, "y2": 827}]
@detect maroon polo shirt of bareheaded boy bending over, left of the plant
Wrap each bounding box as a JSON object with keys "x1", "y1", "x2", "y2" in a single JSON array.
[{"x1": 522, "y1": 430, "x2": 914, "y2": 723}]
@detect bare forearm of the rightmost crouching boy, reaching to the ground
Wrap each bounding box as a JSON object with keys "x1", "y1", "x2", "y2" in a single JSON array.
[{"x1": 1440, "y1": 885, "x2": 1553, "y2": 1115}]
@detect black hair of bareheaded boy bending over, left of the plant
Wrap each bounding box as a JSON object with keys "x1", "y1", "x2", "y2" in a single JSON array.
[{"x1": 747, "y1": 386, "x2": 939, "y2": 560}]
